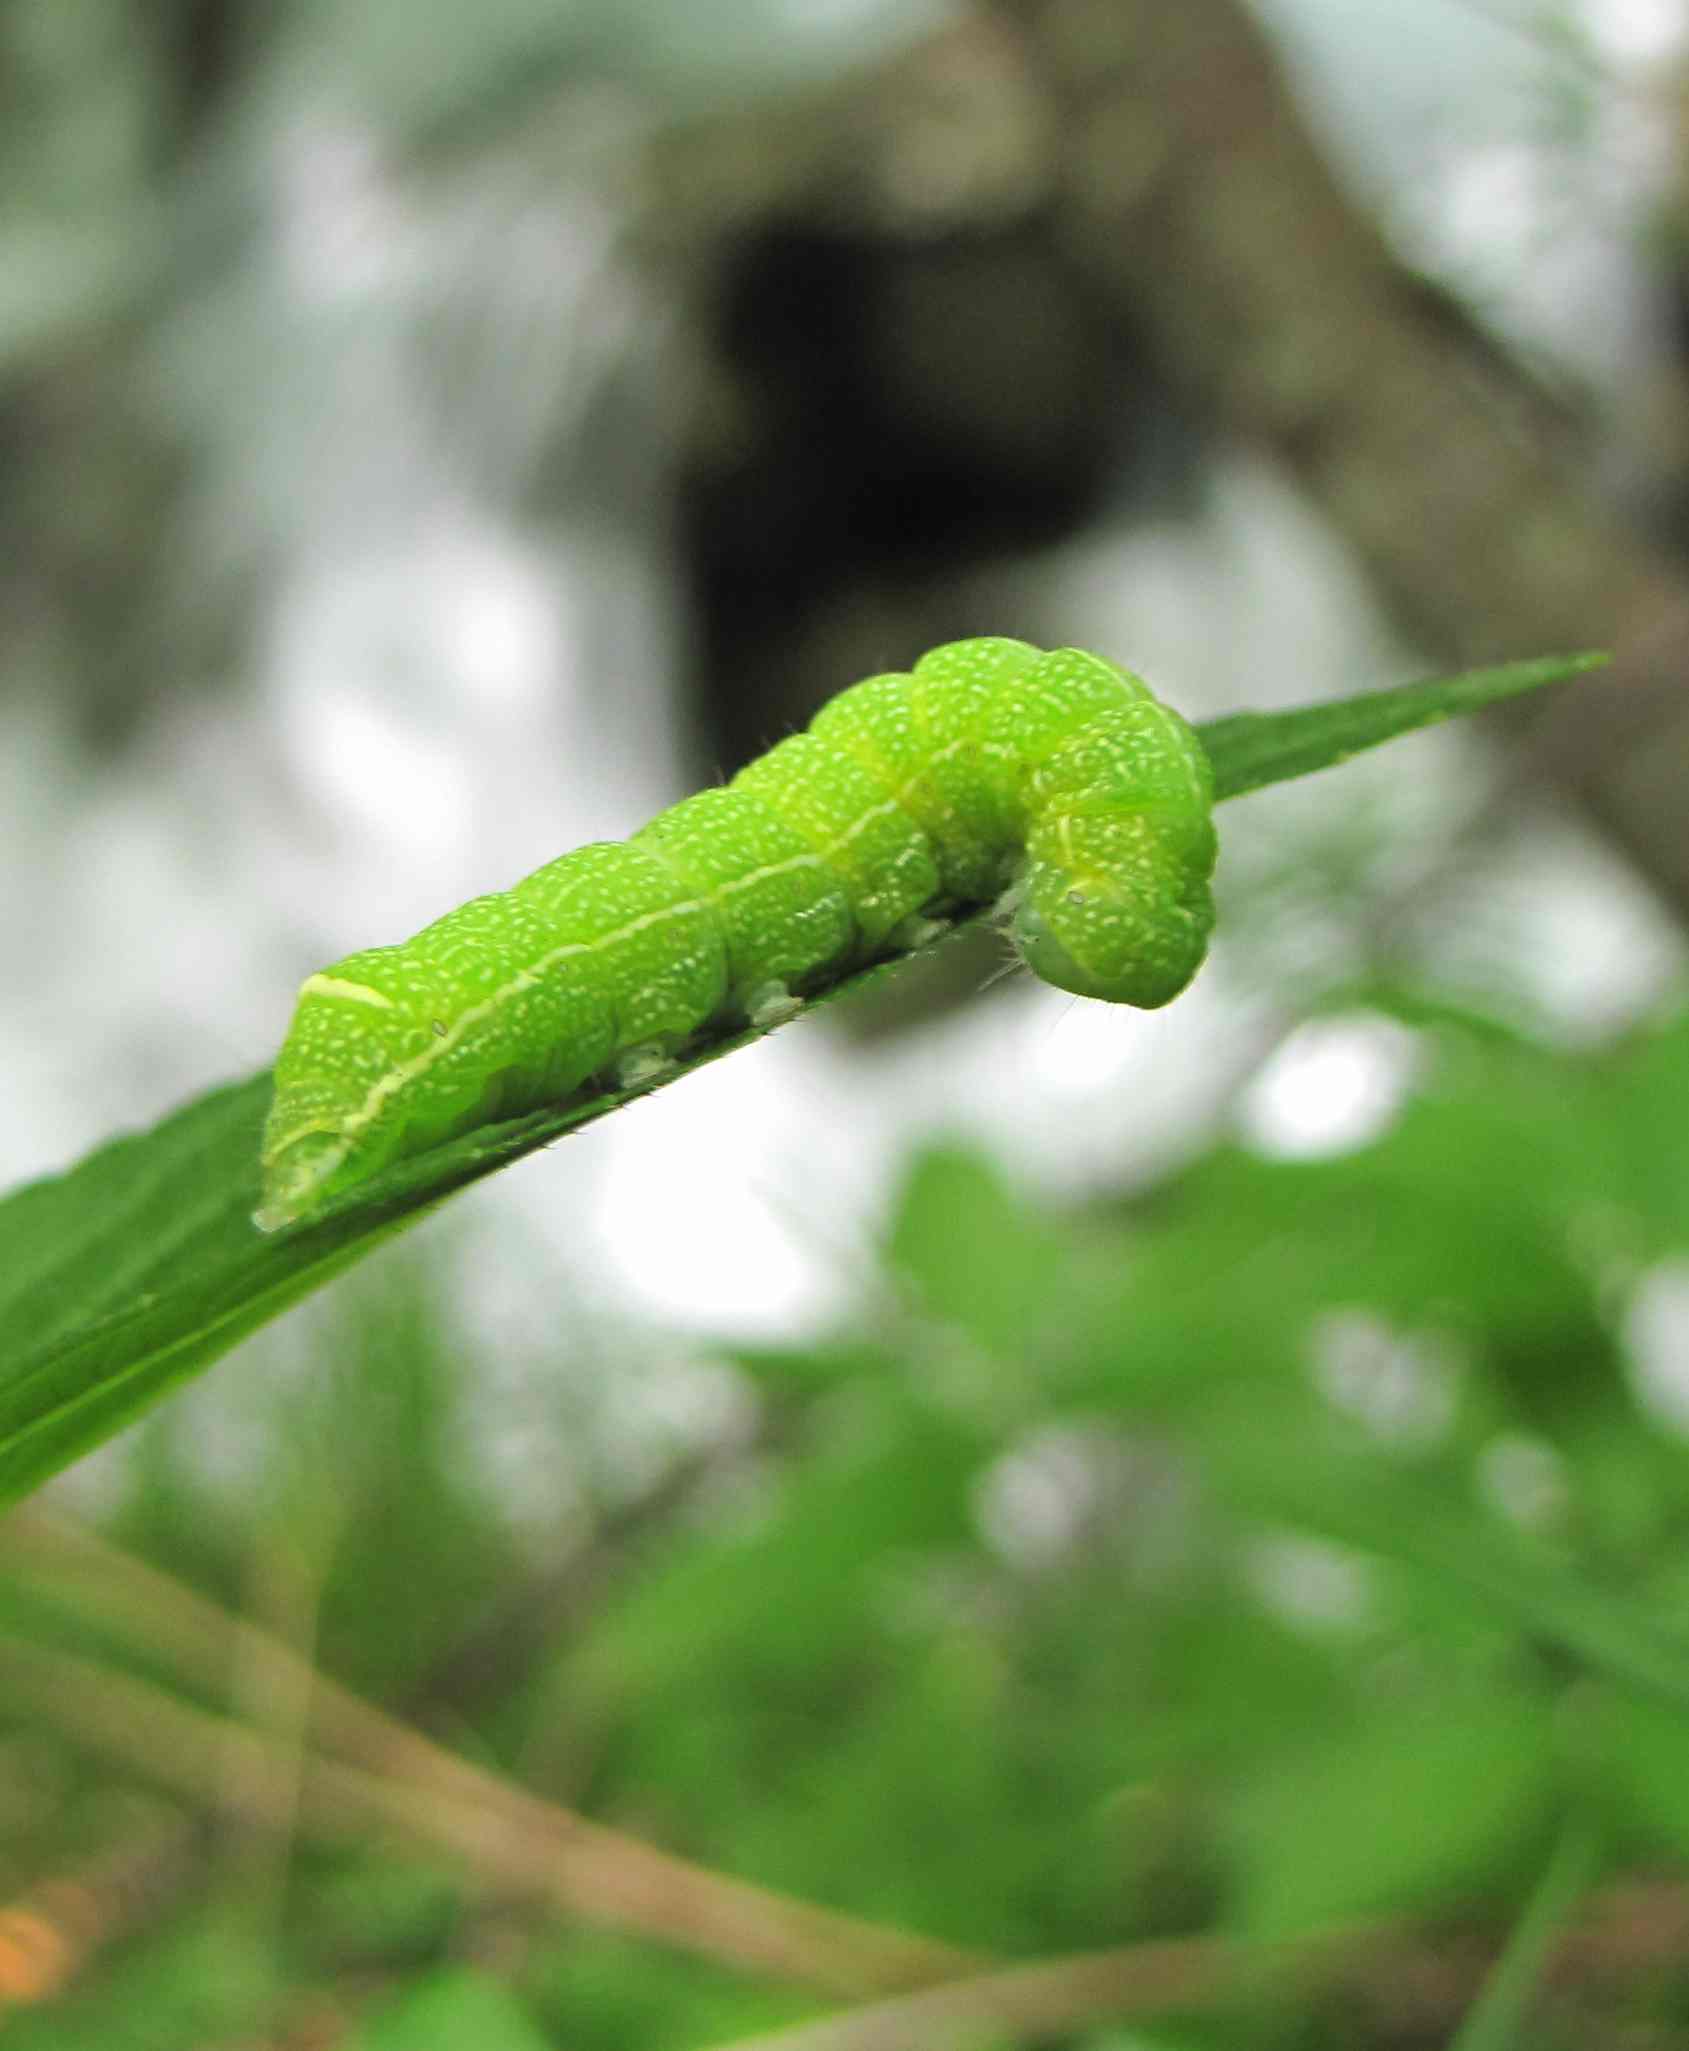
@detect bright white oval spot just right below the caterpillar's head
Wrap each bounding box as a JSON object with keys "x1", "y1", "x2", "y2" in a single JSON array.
[{"x1": 1238, "y1": 1011, "x2": 1423, "y2": 1161}]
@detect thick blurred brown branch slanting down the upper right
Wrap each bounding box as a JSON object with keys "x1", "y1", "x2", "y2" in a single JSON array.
[{"x1": 994, "y1": 0, "x2": 1689, "y2": 913}]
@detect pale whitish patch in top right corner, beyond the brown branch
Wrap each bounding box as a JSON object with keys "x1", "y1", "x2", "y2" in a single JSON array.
[{"x1": 1254, "y1": 0, "x2": 1683, "y2": 394}]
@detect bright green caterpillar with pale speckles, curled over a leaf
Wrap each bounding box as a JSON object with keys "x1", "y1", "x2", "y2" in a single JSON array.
[{"x1": 254, "y1": 640, "x2": 1216, "y2": 1231}]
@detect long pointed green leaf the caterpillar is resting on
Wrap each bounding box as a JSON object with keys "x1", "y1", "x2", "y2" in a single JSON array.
[{"x1": 0, "y1": 654, "x2": 1605, "y2": 1501}]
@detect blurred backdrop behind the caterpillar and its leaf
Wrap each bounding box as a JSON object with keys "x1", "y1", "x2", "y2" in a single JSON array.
[{"x1": 0, "y1": 0, "x2": 1689, "y2": 2051}]
